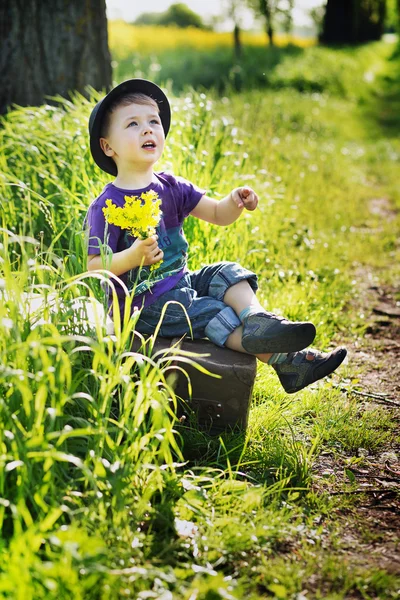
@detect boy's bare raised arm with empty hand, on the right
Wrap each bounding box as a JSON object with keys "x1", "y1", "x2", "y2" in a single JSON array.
[{"x1": 190, "y1": 187, "x2": 258, "y2": 225}]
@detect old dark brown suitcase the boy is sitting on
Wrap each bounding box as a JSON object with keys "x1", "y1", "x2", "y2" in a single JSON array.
[{"x1": 134, "y1": 338, "x2": 257, "y2": 435}]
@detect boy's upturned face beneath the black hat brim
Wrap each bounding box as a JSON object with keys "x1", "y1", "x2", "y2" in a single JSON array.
[{"x1": 100, "y1": 103, "x2": 165, "y2": 173}]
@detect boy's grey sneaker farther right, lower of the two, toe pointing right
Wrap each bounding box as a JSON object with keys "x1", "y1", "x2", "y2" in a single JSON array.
[{"x1": 272, "y1": 348, "x2": 347, "y2": 394}]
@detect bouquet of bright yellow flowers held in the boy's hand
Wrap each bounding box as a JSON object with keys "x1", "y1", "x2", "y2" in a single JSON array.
[{"x1": 103, "y1": 190, "x2": 163, "y2": 271}]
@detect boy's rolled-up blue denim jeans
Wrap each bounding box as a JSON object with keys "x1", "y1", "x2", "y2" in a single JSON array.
[{"x1": 136, "y1": 261, "x2": 258, "y2": 346}]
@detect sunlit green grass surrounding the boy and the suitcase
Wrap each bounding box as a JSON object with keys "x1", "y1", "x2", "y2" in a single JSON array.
[{"x1": 0, "y1": 39, "x2": 400, "y2": 600}]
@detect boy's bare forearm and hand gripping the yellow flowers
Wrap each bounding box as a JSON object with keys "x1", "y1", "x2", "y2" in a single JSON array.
[{"x1": 87, "y1": 235, "x2": 164, "y2": 276}]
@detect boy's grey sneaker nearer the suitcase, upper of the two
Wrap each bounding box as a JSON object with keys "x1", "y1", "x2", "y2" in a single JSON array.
[{"x1": 242, "y1": 312, "x2": 316, "y2": 354}]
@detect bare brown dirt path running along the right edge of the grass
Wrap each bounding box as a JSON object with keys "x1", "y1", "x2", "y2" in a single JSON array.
[{"x1": 314, "y1": 201, "x2": 400, "y2": 584}]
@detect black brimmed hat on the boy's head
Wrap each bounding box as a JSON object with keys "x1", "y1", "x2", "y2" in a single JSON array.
[{"x1": 89, "y1": 79, "x2": 171, "y2": 176}]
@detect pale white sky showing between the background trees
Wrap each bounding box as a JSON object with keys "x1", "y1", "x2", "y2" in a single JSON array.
[{"x1": 106, "y1": 0, "x2": 323, "y2": 29}]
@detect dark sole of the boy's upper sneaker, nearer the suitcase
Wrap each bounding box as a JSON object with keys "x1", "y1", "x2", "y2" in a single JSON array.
[{"x1": 242, "y1": 323, "x2": 317, "y2": 354}]
